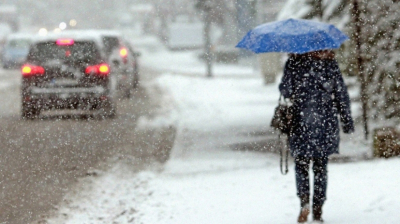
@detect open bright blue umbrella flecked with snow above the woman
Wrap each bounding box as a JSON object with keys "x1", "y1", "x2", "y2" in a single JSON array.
[{"x1": 236, "y1": 19, "x2": 349, "y2": 54}]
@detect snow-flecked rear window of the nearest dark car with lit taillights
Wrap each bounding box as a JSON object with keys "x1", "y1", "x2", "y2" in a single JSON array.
[{"x1": 28, "y1": 42, "x2": 100, "y2": 63}]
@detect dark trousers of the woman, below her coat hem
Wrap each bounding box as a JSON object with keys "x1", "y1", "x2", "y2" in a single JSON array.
[{"x1": 295, "y1": 156, "x2": 328, "y2": 206}]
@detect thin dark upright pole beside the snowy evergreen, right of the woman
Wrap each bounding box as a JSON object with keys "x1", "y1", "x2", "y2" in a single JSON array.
[{"x1": 352, "y1": 0, "x2": 369, "y2": 140}]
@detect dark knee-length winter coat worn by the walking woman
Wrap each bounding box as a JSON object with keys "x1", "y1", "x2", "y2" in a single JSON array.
[{"x1": 279, "y1": 56, "x2": 354, "y2": 158}]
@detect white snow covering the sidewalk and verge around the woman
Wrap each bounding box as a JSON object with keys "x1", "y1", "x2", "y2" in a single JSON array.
[{"x1": 48, "y1": 34, "x2": 400, "y2": 224}]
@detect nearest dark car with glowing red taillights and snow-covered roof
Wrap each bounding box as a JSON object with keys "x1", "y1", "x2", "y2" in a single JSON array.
[{"x1": 21, "y1": 33, "x2": 118, "y2": 119}]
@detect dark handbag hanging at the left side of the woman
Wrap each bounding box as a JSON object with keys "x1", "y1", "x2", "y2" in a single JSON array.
[{"x1": 271, "y1": 95, "x2": 293, "y2": 135}]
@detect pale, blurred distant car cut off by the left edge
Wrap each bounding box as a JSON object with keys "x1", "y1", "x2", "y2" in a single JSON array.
[{"x1": 1, "y1": 33, "x2": 32, "y2": 69}]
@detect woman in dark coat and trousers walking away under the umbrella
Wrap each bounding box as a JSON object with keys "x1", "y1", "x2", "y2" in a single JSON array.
[{"x1": 279, "y1": 50, "x2": 354, "y2": 223}]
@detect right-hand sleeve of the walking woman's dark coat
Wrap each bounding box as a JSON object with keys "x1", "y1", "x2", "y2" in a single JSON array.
[{"x1": 332, "y1": 61, "x2": 354, "y2": 133}]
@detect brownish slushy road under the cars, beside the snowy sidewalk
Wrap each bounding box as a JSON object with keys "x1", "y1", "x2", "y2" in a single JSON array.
[{"x1": 0, "y1": 70, "x2": 175, "y2": 224}]
